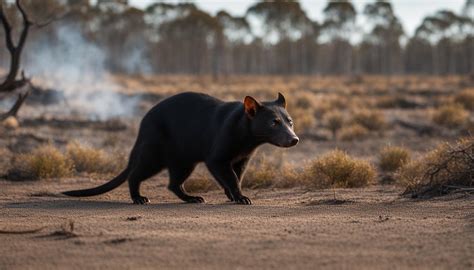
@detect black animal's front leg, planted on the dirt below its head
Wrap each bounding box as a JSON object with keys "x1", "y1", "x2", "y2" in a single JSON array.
[{"x1": 206, "y1": 161, "x2": 252, "y2": 204}]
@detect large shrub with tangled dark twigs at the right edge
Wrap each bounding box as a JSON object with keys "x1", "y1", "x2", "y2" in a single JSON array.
[{"x1": 396, "y1": 137, "x2": 474, "y2": 197}]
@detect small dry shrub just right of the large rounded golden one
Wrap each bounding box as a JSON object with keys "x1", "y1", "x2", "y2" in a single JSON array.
[{"x1": 379, "y1": 146, "x2": 410, "y2": 172}]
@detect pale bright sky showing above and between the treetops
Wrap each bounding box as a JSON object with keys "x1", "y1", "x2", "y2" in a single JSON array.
[{"x1": 129, "y1": 0, "x2": 466, "y2": 36}]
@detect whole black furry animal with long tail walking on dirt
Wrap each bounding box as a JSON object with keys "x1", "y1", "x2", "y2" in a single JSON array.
[{"x1": 64, "y1": 93, "x2": 299, "y2": 204}]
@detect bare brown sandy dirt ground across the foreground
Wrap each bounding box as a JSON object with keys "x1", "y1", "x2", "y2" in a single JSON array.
[{"x1": 0, "y1": 178, "x2": 474, "y2": 269}]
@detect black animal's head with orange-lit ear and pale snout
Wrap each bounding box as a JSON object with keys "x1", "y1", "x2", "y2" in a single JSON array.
[{"x1": 244, "y1": 93, "x2": 299, "y2": 147}]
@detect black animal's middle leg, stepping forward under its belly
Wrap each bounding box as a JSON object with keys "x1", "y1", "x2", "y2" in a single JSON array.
[{"x1": 168, "y1": 164, "x2": 204, "y2": 203}]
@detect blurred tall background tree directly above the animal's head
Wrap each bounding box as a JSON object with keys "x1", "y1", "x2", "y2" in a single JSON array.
[{"x1": 246, "y1": 0, "x2": 318, "y2": 73}]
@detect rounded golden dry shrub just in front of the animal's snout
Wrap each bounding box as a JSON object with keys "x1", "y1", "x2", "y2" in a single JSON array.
[{"x1": 304, "y1": 150, "x2": 376, "y2": 188}]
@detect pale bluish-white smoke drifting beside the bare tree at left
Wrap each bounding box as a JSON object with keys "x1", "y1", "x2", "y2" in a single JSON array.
[{"x1": 25, "y1": 25, "x2": 141, "y2": 120}]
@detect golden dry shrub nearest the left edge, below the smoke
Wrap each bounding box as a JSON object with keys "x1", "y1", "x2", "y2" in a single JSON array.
[{"x1": 7, "y1": 145, "x2": 73, "y2": 180}]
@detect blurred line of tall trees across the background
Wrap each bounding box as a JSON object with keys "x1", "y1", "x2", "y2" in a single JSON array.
[{"x1": 0, "y1": 0, "x2": 474, "y2": 76}]
